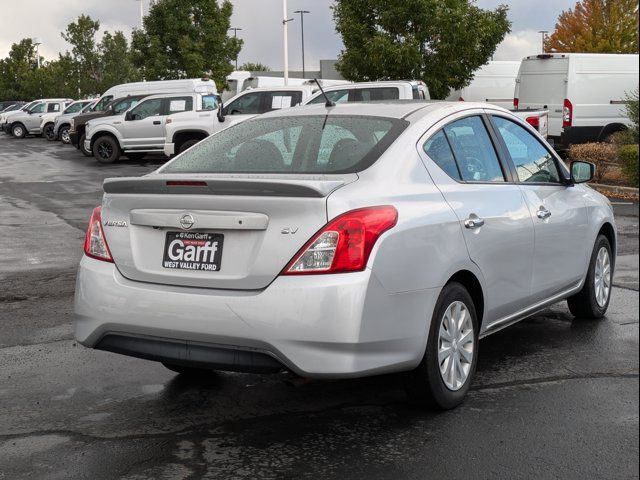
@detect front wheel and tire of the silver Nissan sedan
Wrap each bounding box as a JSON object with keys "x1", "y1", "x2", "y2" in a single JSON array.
[{"x1": 567, "y1": 235, "x2": 615, "y2": 320}]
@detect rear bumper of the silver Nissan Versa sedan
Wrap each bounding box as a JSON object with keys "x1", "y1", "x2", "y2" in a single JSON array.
[{"x1": 75, "y1": 257, "x2": 439, "y2": 378}]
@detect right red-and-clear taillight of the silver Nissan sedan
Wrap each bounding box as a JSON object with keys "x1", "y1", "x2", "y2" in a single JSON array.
[{"x1": 283, "y1": 206, "x2": 398, "y2": 275}]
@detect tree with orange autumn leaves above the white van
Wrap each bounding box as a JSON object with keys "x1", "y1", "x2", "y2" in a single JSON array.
[{"x1": 545, "y1": 0, "x2": 638, "y2": 53}]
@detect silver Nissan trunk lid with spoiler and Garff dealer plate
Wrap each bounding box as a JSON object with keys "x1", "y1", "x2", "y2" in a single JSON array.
[{"x1": 102, "y1": 174, "x2": 358, "y2": 290}]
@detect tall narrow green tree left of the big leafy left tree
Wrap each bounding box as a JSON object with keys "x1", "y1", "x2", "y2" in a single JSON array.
[{"x1": 61, "y1": 15, "x2": 100, "y2": 95}]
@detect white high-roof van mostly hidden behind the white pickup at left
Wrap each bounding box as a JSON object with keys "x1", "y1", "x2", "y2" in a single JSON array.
[{"x1": 92, "y1": 78, "x2": 218, "y2": 116}]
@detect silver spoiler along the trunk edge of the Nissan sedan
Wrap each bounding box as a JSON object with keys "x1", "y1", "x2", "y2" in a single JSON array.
[{"x1": 103, "y1": 174, "x2": 350, "y2": 198}]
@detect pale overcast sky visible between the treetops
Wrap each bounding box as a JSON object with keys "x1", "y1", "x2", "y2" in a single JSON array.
[{"x1": 0, "y1": 0, "x2": 576, "y2": 69}]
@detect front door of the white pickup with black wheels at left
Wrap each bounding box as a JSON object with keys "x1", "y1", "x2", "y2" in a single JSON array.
[{"x1": 121, "y1": 98, "x2": 167, "y2": 150}]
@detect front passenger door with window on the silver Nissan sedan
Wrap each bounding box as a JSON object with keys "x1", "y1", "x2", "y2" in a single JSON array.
[{"x1": 492, "y1": 115, "x2": 593, "y2": 301}]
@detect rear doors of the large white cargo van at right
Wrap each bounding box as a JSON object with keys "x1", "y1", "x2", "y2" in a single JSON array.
[{"x1": 516, "y1": 55, "x2": 569, "y2": 137}]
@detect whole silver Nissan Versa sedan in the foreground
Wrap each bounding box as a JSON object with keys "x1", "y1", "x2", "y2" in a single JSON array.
[{"x1": 75, "y1": 102, "x2": 616, "y2": 408}]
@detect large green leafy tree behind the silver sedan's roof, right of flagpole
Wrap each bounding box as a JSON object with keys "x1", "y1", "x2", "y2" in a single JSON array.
[{"x1": 333, "y1": 0, "x2": 511, "y2": 98}]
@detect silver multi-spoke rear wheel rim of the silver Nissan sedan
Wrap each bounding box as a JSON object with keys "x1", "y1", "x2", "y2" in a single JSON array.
[{"x1": 438, "y1": 301, "x2": 475, "y2": 391}]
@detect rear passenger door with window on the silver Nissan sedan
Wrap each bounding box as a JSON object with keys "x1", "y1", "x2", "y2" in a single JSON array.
[{"x1": 423, "y1": 114, "x2": 534, "y2": 327}]
